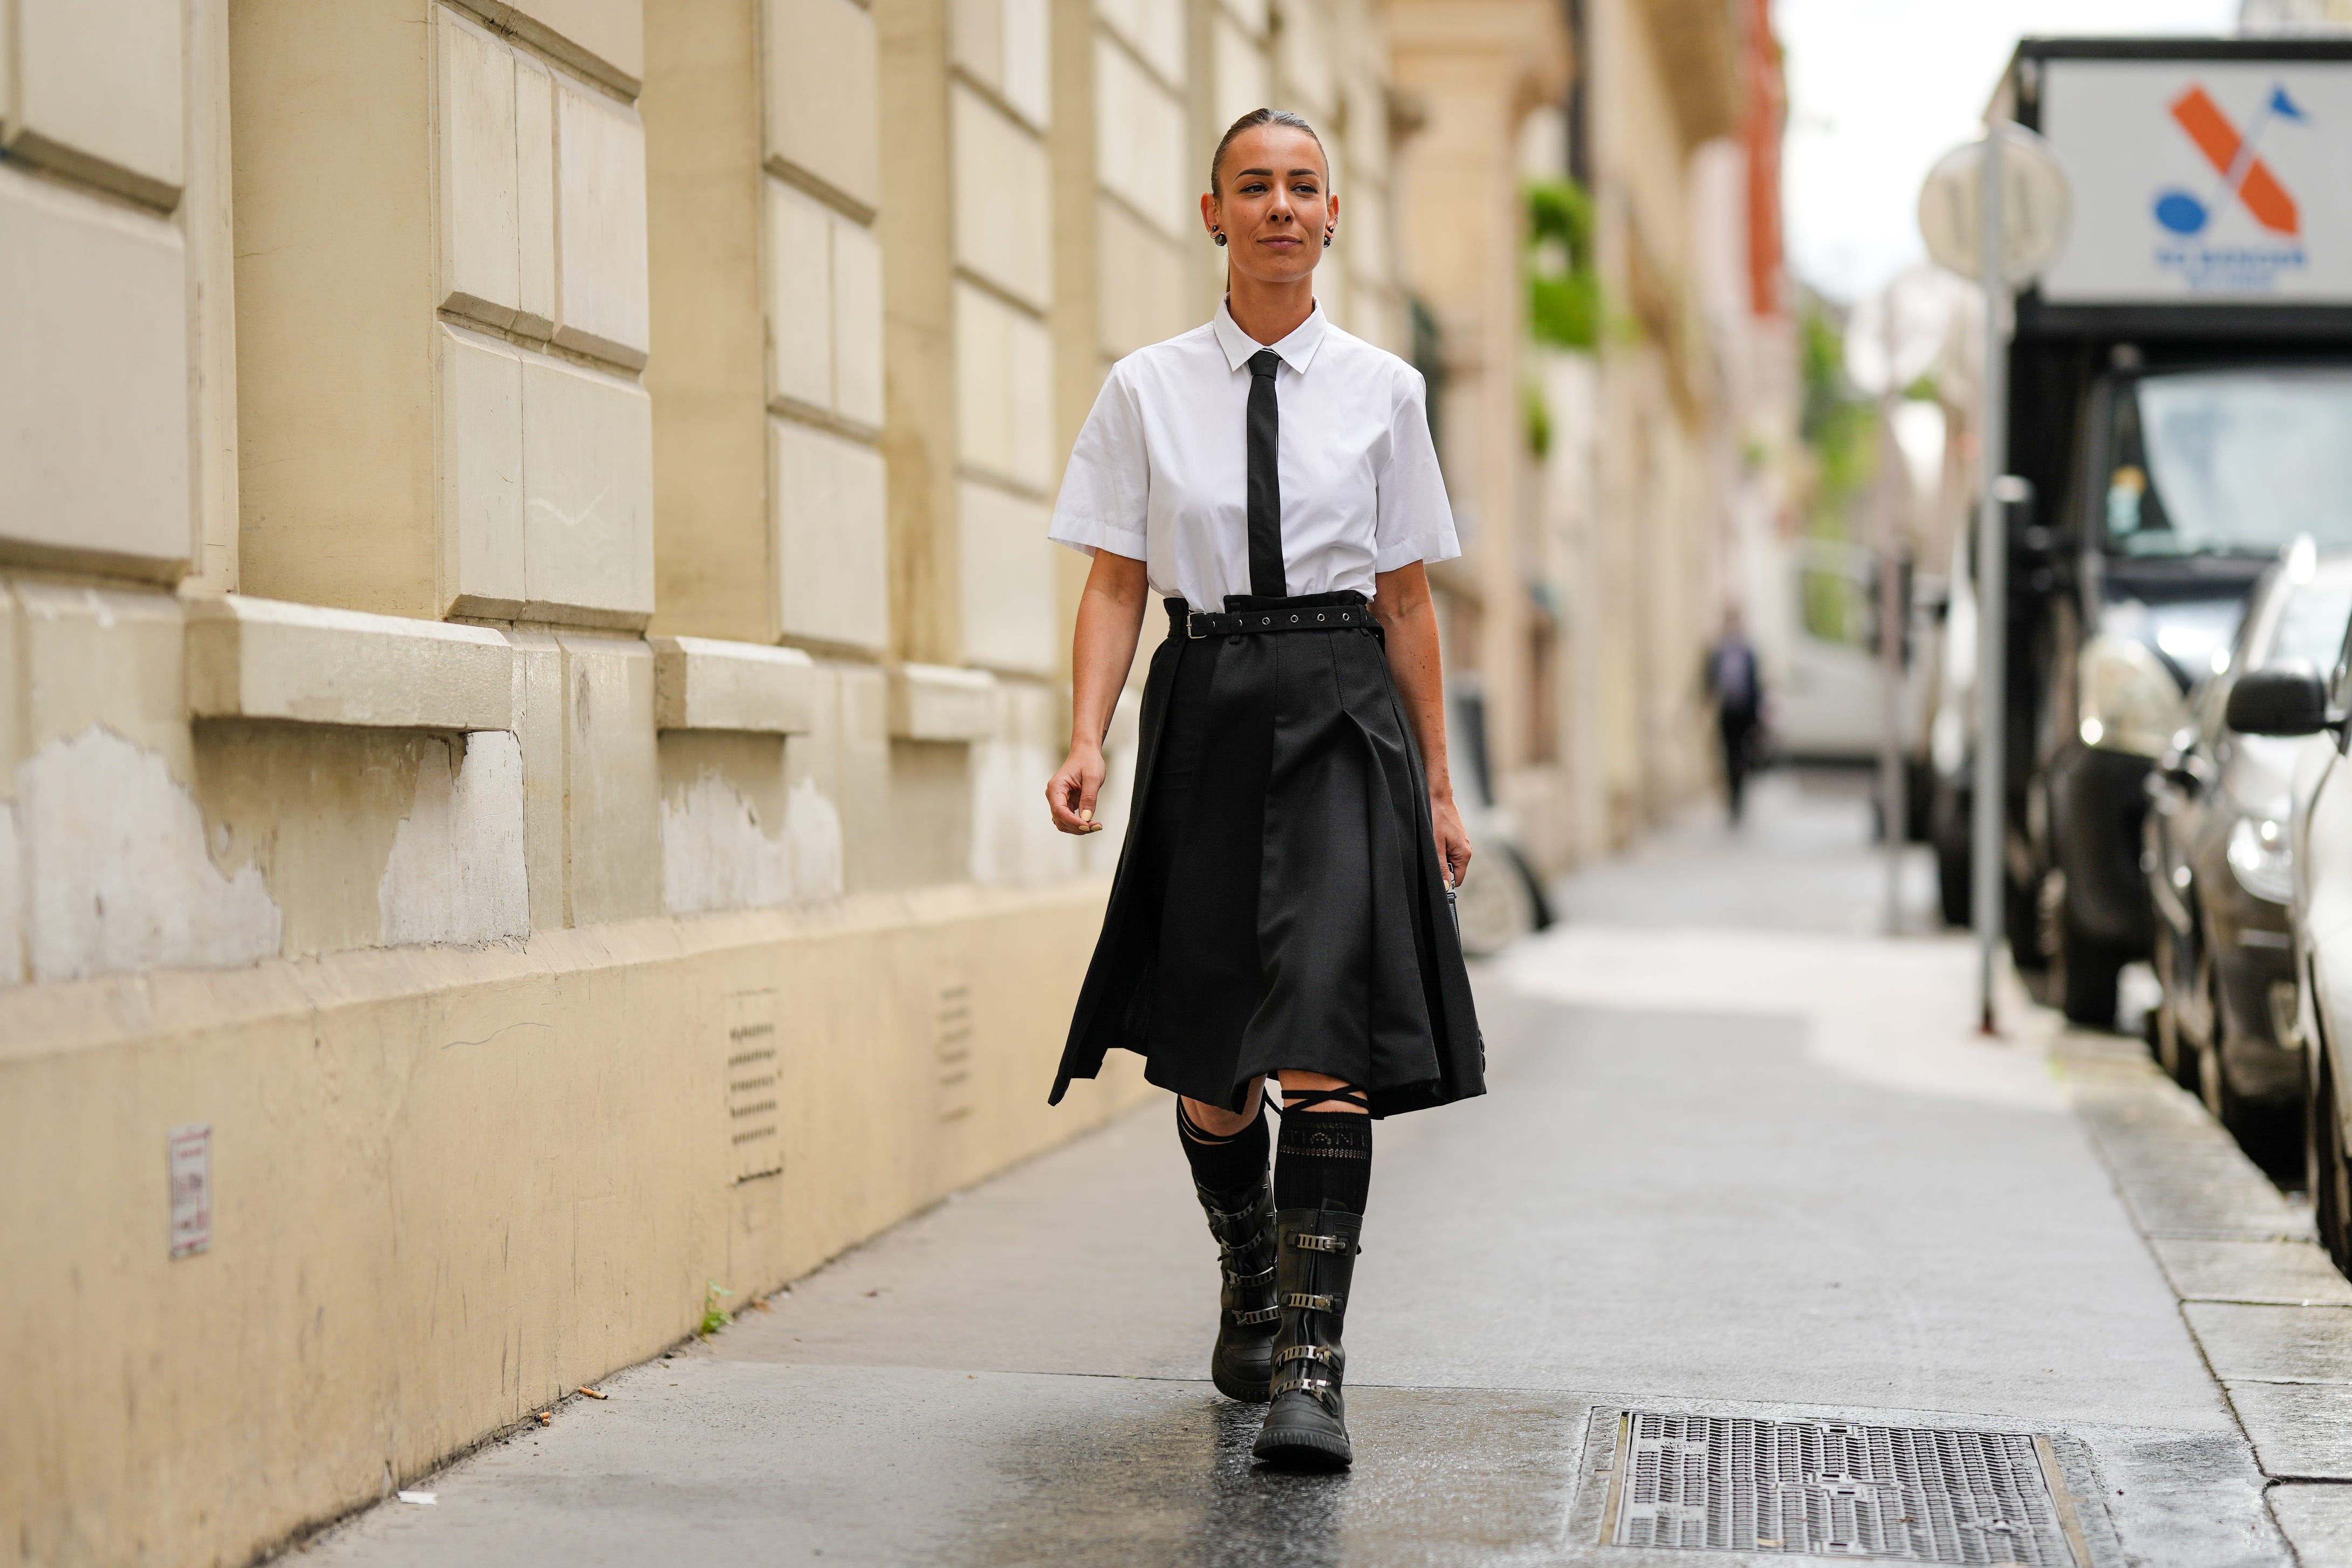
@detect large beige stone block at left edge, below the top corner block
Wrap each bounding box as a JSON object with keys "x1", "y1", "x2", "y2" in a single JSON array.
[{"x1": 0, "y1": 167, "x2": 195, "y2": 578}]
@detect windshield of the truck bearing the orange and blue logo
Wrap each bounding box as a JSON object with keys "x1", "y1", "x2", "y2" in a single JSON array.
[{"x1": 2108, "y1": 369, "x2": 2352, "y2": 557}]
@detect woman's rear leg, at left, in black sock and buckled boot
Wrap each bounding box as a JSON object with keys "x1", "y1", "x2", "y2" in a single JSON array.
[{"x1": 1176, "y1": 1079, "x2": 1282, "y2": 1403}]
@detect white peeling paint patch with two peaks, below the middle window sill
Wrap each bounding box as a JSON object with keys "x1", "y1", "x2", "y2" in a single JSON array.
[{"x1": 661, "y1": 771, "x2": 842, "y2": 914}]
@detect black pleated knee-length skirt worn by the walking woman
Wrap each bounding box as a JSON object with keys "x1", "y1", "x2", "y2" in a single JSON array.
[{"x1": 1051, "y1": 592, "x2": 1487, "y2": 1117}]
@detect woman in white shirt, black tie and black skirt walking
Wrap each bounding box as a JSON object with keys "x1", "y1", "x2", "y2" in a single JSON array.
[{"x1": 1047, "y1": 108, "x2": 1484, "y2": 1469}]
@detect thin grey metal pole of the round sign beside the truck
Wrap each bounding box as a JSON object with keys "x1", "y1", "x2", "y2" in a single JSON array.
[{"x1": 1971, "y1": 120, "x2": 2008, "y2": 1035}]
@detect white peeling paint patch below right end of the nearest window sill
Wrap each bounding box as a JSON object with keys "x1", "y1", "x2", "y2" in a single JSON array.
[{"x1": 377, "y1": 729, "x2": 531, "y2": 947}]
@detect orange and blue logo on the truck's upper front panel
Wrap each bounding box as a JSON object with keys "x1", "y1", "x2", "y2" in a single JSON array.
[{"x1": 2155, "y1": 85, "x2": 2307, "y2": 291}]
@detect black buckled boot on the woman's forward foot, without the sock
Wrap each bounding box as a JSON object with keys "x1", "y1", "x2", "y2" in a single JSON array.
[{"x1": 1252, "y1": 1208, "x2": 1364, "y2": 1469}]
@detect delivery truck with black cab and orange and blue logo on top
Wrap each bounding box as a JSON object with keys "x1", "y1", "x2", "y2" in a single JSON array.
[{"x1": 1933, "y1": 38, "x2": 2352, "y2": 1023}]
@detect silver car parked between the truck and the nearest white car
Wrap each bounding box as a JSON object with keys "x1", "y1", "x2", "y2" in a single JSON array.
[{"x1": 2141, "y1": 540, "x2": 2352, "y2": 1163}]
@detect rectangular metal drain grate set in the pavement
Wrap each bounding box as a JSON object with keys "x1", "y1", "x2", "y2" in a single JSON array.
[{"x1": 1602, "y1": 1410, "x2": 2091, "y2": 1568}]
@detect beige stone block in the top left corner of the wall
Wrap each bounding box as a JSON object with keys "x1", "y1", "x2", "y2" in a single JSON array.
[{"x1": 0, "y1": 0, "x2": 186, "y2": 211}]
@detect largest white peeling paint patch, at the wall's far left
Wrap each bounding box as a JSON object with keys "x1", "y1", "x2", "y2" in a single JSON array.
[{"x1": 17, "y1": 724, "x2": 285, "y2": 980}]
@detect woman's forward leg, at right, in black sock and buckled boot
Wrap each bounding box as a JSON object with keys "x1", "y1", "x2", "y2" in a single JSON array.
[{"x1": 1254, "y1": 1072, "x2": 1371, "y2": 1469}]
